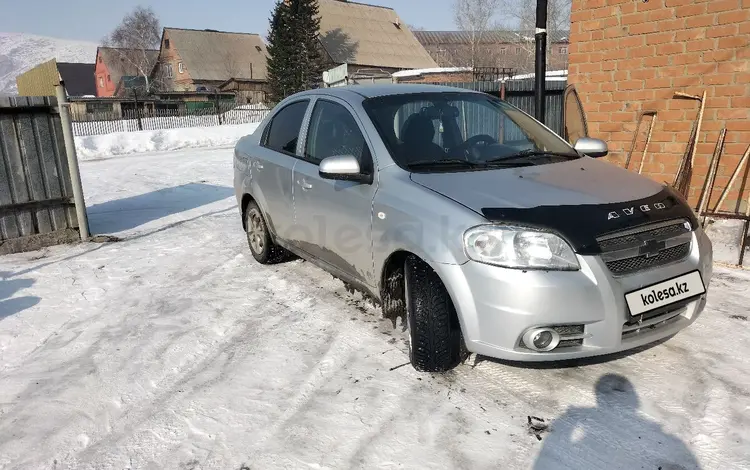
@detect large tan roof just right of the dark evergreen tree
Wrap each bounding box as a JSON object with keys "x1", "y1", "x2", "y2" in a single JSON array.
[{"x1": 319, "y1": 0, "x2": 437, "y2": 69}]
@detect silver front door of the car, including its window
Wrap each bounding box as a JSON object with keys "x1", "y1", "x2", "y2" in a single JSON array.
[{"x1": 292, "y1": 97, "x2": 377, "y2": 286}]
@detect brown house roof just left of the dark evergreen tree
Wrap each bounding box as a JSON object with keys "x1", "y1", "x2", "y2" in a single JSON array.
[{"x1": 164, "y1": 28, "x2": 267, "y2": 81}]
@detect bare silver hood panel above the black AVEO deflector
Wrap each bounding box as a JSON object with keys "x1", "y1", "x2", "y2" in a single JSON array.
[{"x1": 411, "y1": 157, "x2": 663, "y2": 213}]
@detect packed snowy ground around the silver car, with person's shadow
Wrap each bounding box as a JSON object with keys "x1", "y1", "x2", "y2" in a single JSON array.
[{"x1": 0, "y1": 149, "x2": 750, "y2": 470}]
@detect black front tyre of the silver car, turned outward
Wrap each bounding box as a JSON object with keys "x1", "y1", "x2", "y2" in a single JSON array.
[{"x1": 404, "y1": 256, "x2": 463, "y2": 372}]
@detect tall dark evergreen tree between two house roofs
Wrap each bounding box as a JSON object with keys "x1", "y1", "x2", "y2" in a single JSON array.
[{"x1": 268, "y1": 0, "x2": 323, "y2": 103}]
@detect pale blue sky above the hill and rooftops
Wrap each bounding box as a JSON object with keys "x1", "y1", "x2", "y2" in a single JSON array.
[{"x1": 0, "y1": 0, "x2": 455, "y2": 42}]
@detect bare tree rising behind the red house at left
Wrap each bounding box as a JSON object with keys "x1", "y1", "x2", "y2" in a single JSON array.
[{"x1": 103, "y1": 6, "x2": 161, "y2": 92}]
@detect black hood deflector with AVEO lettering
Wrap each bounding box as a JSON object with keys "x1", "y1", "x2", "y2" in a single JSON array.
[{"x1": 482, "y1": 186, "x2": 698, "y2": 255}]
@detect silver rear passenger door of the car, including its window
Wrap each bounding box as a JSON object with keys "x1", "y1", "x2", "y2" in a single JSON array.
[{"x1": 250, "y1": 99, "x2": 310, "y2": 240}]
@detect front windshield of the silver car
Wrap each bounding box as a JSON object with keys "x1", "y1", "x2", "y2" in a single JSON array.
[{"x1": 364, "y1": 92, "x2": 580, "y2": 172}]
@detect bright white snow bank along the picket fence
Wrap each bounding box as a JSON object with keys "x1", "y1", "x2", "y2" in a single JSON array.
[{"x1": 75, "y1": 123, "x2": 258, "y2": 160}]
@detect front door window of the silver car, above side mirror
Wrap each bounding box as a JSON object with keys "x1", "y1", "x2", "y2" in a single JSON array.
[{"x1": 305, "y1": 100, "x2": 370, "y2": 166}]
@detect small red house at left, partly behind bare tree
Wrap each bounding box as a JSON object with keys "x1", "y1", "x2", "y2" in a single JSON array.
[{"x1": 94, "y1": 47, "x2": 159, "y2": 98}]
